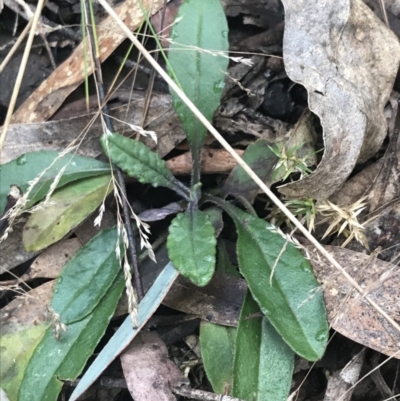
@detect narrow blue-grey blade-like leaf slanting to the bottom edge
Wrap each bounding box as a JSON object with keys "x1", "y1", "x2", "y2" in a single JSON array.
[{"x1": 69, "y1": 263, "x2": 178, "y2": 401}]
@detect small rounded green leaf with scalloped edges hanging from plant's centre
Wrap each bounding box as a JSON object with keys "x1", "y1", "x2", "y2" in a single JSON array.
[{"x1": 167, "y1": 210, "x2": 217, "y2": 287}]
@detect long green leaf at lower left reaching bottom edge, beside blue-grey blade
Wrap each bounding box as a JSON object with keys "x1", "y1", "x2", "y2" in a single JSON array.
[{"x1": 18, "y1": 272, "x2": 124, "y2": 401}]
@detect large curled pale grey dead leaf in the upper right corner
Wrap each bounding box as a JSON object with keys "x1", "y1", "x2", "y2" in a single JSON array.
[{"x1": 280, "y1": 0, "x2": 400, "y2": 200}]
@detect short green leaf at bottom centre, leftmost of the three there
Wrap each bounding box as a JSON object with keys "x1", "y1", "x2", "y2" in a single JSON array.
[{"x1": 200, "y1": 322, "x2": 236, "y2": 395}]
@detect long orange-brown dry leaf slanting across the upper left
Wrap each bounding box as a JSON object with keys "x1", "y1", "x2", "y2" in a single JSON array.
[{"x1": 12, "y1": 0, "x2": 168, "y2": 124}]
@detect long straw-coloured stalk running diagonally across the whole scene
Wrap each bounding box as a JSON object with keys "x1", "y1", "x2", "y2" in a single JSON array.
[{"x1": 99, "y1": 0, "x2": 400, "y2": 333}]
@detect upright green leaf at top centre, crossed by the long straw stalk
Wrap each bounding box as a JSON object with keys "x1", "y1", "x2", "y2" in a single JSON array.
[{"x1": 168, "y1": 0, "x2": 229, "y2": 179}]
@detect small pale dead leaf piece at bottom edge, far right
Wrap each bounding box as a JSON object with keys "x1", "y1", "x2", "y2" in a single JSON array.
[{"x1": 324, "y1": 348, "x2": 366, "y2": 401}]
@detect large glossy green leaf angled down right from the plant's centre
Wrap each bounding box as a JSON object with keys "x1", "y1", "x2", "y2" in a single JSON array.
[{"x1": 224, "y1": 205, "x2": 328, "y2": 361}]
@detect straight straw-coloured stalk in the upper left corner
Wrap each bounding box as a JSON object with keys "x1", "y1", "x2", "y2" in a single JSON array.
[{"x1": 0, "y1": 0, "x2": 45, "y2": 161}]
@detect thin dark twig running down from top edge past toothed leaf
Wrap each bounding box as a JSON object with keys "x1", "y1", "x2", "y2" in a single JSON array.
[{"x1": 85, "y1": 0, "x2": 144, "y2": 302}]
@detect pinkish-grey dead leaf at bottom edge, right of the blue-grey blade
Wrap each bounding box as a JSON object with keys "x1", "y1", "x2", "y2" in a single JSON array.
[{"x1": 121, "y1": 331, "x2": 189, "y2": 401}]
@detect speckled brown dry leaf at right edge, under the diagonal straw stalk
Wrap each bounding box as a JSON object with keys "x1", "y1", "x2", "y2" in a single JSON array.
[{"x1": 311, "y1": 246, "x2": 400, "y2": 359}]
